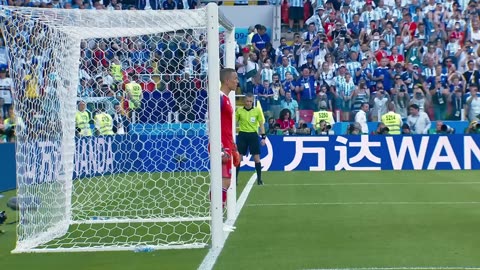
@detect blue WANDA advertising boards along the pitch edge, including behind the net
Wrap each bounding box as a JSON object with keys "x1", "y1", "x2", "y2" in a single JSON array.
[{"x1": 0, "y1": 134, "x2": 480, "y2": 191}]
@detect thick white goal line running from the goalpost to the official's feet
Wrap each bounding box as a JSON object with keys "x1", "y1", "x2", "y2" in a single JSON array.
[{"x1": 198, "y1": 173, "x2": 257, "y2": 270}]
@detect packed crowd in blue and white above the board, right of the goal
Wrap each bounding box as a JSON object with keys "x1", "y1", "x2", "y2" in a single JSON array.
[{"x1": 242, "y1": 0, "x2": 480, "y2": 134}]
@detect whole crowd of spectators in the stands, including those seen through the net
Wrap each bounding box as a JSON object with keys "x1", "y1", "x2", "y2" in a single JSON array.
[{"x1": 0, "y1": 0, "x2": 480, "y2": 141}]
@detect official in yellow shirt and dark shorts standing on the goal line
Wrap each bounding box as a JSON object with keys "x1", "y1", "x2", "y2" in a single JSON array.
[{"x1": 235, "y1": 93, "x2": 267, "y2": 185}]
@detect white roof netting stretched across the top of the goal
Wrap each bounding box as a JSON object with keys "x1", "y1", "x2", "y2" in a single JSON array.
[{"x1": 0, "y1": 6, "x2": 234, "y2": 39}]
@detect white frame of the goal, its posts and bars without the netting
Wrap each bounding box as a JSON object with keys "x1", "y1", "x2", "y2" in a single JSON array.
[{"x1": 0, "y1": 3, "x2": 236, "y2": 253}]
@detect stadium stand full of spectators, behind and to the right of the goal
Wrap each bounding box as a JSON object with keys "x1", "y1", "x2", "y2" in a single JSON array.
[{"x1": 0, "y1": 0, "x2": 480, "y2": 146}]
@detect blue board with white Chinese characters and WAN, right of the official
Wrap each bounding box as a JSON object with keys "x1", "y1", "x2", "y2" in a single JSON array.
[{"x1": 242, "y1": 135, "x2": 480, "y2": 171}]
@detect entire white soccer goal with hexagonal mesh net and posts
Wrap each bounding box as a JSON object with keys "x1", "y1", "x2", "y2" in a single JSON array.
[{"x1": 0, "y1": 4, "x2": 235, "y2": 253}]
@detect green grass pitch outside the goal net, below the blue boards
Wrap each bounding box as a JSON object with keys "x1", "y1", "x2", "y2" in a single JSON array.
[{"x1": 0, "y1": 171, "x2": 480, "y2": 270}]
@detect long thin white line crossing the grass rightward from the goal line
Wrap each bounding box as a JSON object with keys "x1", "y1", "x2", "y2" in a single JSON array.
[{"x1": 246, "y1": 201, "x2": 480, "y2": 207}]
